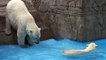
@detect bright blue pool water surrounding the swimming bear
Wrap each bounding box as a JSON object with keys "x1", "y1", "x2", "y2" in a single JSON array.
[{"x1": 0, "y1": 39, "x2": 106, "y2": 60}]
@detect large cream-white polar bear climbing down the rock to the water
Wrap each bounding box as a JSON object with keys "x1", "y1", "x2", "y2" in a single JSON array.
[{"x1": 5, "y1": 0, "x2": 41, "y2": 47}]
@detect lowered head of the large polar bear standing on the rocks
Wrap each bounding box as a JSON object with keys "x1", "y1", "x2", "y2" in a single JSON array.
[{"x1": 27, "y1": 28, "x2": 41, "y2": 43}]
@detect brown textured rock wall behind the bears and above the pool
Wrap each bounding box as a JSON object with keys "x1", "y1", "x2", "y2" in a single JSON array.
[{"x1": 0, "y1": 0, "x2": 106, "y2": 44}]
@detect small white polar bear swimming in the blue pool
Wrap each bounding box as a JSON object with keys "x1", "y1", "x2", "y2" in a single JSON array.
[{"x1": 63, "y1": 43, "x2": 97, "y2": 56}]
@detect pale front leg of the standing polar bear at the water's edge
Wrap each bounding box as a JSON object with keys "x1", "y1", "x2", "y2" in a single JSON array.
[{"x1": 17, "y1": 29, "x2": 27, "y2": 48}]
